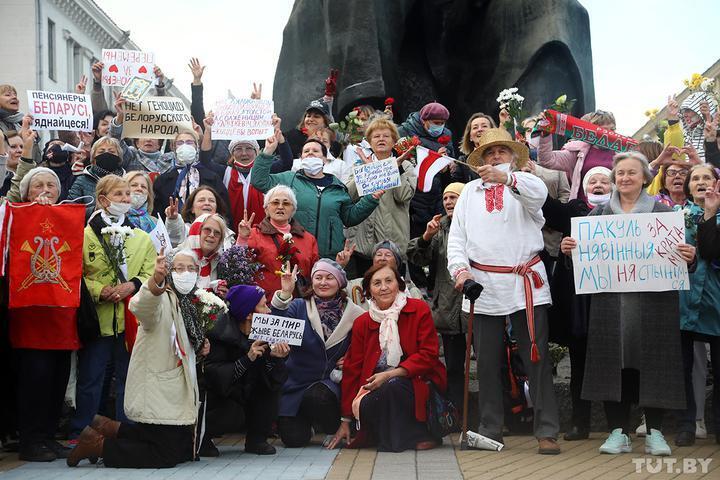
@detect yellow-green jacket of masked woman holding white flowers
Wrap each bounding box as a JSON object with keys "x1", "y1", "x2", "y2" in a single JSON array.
[{"x1": 83, "y1": 226, "x2": 157, "y2": 337}]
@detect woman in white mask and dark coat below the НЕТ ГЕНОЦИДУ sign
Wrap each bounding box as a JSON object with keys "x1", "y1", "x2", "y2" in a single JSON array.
[{"x1": 153, "y1": 127, "x2": 228, "y2": 220}]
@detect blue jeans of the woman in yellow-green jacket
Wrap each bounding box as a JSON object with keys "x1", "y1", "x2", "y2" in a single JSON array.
[{"x1": 70, "y1": 333, "x2": 130, "y2": 438}]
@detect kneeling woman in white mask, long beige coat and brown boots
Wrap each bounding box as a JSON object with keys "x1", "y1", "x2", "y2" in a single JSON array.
[{"x1": 67, "y1": 250, "x2": 202, "y2": 468}]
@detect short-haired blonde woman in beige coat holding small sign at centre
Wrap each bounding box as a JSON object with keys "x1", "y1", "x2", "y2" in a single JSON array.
[{"x1": 348, "y1": 118, "x2": 417, "y2": 272}]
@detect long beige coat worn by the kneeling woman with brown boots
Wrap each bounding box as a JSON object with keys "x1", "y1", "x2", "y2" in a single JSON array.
[{"x1": 125, "y1": 283, "x2": 199, "y2": 425}]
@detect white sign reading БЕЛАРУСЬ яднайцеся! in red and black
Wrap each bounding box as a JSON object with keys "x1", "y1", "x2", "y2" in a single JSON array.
[{"x1": 28, "y1": 90, "x2": 93, "y2": 132}]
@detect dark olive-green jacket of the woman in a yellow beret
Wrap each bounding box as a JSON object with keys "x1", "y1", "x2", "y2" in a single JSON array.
[{"x1": 407, "y1": 215, "x2": 467, "y2": 335}]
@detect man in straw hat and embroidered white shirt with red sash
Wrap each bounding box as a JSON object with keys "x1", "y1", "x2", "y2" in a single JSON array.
[{"x1": 447, "y1": 129, "x2": 560, "y2": 455}]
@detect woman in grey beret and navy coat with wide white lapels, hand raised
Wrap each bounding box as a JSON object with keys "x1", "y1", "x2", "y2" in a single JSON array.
[{"x1": 272, "y1": 258, "x2": 364, "y2": 447}]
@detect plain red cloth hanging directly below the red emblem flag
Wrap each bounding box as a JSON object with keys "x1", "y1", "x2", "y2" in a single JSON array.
[{"x1": 9, "y1": 307, "x2": 80, "y2": 350}]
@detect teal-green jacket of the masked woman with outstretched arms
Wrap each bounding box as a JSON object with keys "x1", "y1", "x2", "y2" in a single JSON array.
[{"x1": 250, "y1": 153, "x2": 378, "y2": 259}]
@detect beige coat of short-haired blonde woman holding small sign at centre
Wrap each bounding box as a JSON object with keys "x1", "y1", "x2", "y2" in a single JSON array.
[{"x1": 346, "y1": 160, "x2": 417, "y2": 258}]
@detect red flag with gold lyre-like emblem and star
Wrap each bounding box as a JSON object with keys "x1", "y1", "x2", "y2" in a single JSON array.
[{"x1": 6, "y1": 203, "x2": 85, "y2": 308}]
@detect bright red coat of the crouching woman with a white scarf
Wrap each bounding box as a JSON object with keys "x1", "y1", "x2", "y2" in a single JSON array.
[{"x1": 341, "y1": 298, "x2": 447, "y2": 422}]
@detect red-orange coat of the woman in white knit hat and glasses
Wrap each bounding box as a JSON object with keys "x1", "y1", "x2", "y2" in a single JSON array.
[{"x1": 247, "y1": 218, "x2": 320, "y2": 303}]
